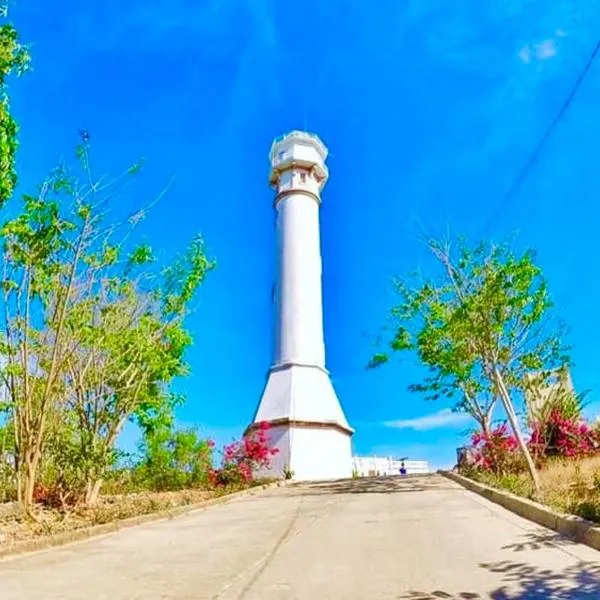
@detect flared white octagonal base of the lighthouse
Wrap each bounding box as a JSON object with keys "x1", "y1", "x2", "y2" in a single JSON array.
[{"x1": 248, "y1": 365, "x2": 354, "y2": 481}]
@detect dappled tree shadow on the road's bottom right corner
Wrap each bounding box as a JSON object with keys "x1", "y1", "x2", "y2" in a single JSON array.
[{"x1": 398, "y1": 561, "x2": 600, "y2": 600}]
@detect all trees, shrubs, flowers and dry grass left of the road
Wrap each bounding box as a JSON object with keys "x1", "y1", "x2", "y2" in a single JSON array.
[{"x1": 0, "y1": 11, "x2": 275, "y2": 545}]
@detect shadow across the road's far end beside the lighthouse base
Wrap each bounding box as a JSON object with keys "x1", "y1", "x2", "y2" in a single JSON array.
[{"x1": 292, "y1": 475, "x2": 456, "y2": 496}]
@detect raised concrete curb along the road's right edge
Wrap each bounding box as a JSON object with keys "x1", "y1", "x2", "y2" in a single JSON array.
[{"x1": 440, "y1": 471, "x2": 600, "y2": 550}]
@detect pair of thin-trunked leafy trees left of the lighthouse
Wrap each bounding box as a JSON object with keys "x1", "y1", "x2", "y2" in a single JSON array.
[{"x1": 0, "y1": 137, "x2": 213, "y2": 508}]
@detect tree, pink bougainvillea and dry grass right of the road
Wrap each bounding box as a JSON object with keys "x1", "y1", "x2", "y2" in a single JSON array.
[{"x1": 370, "y1": 234, "x2": 600, "y2": 521}]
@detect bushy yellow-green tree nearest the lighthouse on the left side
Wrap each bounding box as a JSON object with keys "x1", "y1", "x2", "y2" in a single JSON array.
[{"x1": 65, "y1": 232, "x2": 212, "y2": 504}]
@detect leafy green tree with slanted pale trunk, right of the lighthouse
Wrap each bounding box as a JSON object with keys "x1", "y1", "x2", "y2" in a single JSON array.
[{"x1": 371, "y1": 240, "x2": 568, "y2": 492}]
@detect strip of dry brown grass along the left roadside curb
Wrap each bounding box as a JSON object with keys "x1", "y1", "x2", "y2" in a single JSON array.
[{"x1": 0, "y1": 490, "x2": 216, "y2": 548}]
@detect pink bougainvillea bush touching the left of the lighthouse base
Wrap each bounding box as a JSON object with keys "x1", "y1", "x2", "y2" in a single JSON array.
[{"x1": 210, "y1": 421, "x2": 279, "y2": 487}]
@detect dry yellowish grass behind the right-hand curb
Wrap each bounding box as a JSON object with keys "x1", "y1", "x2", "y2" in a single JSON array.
[{"x1": 465, "y1": 456, "x2": 600, "y2": 523}]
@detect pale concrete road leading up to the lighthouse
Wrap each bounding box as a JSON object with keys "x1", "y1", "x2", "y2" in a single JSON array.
[{"x1": 0, "y1": 475, "x2": 600, "y2": 600}]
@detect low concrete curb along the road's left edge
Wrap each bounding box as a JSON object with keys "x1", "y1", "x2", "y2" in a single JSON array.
[{"x1": 0, "y1": 481, "x2": 285, "y2": 561}]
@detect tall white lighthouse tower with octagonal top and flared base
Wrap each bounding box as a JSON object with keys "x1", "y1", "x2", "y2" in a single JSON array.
[{"x1": 247, "y1": 131, "x2": 353, "y2": 480}]
